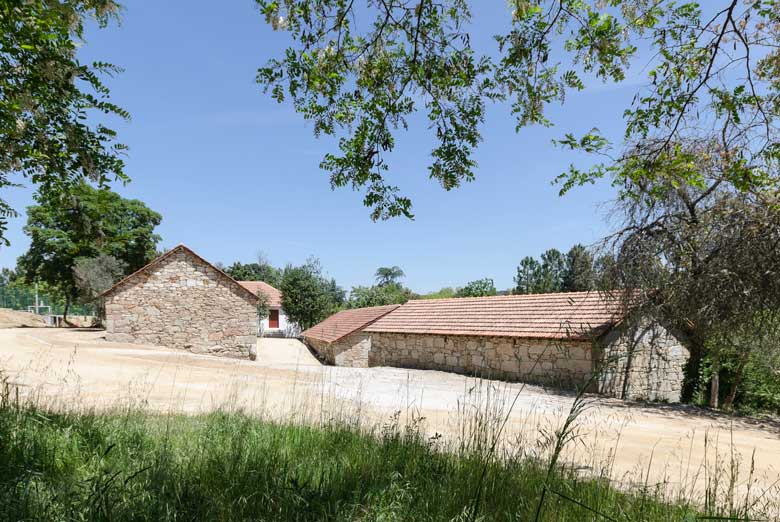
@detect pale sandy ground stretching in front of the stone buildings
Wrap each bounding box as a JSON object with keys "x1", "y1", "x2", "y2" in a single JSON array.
[{"x1": 0, "y1": 328, "x2": 780, "y2": 503}]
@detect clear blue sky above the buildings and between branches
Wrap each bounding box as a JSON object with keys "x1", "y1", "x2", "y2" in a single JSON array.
[{"x1": 0, "y1": 0, "x2": 636, "y2": 292}]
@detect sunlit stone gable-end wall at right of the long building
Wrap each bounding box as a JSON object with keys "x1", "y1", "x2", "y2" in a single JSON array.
[{"x1": 599, "y1": 325, "x2": 689, "y2": 402}]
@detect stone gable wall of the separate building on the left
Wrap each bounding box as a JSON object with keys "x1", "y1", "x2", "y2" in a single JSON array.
[{"x1": 106, "y1": 250, "x2": 257, "y2": 358}]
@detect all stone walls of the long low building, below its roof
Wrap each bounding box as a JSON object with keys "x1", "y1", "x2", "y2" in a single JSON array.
[{"x1": 307, "y1": 326, "x2": 688, "y2": 402}]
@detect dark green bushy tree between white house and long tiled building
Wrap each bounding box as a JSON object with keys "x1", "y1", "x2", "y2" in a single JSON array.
[{"x1": 279, "y1": 259, "x2": 343, "y2": 329}]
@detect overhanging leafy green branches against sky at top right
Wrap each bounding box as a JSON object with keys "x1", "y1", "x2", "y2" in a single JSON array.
[{"x1": 257, "y1": 0, "x2": 780, "y2": 215}]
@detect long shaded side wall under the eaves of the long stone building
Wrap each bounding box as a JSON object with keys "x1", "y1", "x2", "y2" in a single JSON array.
[{"x1": 368, "y1": 333, "x2": 593, "y2": 387}]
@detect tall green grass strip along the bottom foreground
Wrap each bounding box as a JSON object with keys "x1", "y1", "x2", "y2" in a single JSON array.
[{"x1": 0, "y1": 401, "x2": 712, "y2": 522}]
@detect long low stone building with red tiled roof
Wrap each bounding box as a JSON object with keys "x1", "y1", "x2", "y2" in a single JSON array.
[{"x1": 303, "y1": 292, "x2": 688, "y2": 402}]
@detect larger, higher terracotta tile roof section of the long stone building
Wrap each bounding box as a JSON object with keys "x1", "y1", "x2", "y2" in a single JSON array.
[{"x1": 365, "y1": 292, "x2": 626, "y2": 340}]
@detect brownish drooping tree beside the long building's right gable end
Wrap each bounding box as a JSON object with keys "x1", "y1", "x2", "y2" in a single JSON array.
[{"x1": 610, "y1": 142, "x2": 780, "y2": 400}]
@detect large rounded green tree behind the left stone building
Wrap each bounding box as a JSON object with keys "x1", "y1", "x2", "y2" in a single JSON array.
[{"x1": 18, "y1": 182, "x2": 162, "y2": 318}]
